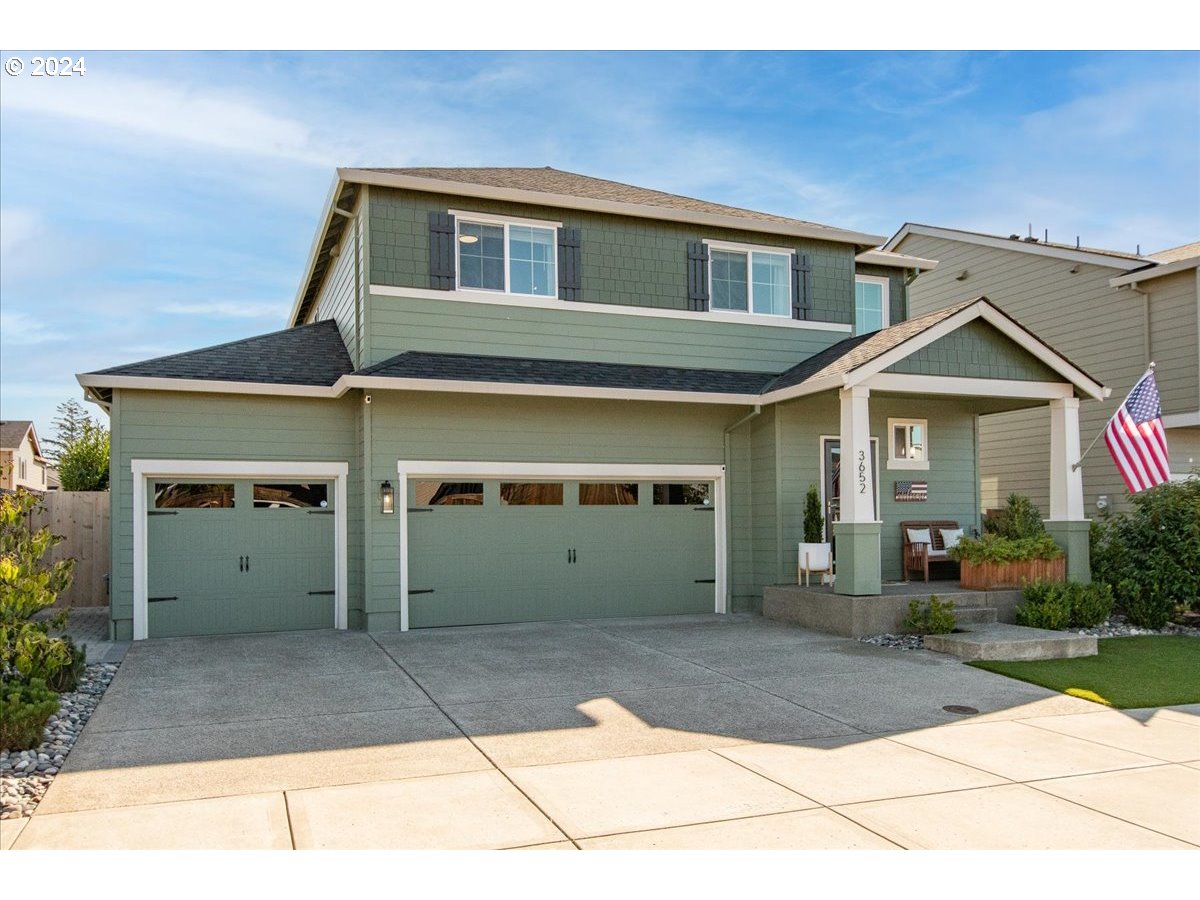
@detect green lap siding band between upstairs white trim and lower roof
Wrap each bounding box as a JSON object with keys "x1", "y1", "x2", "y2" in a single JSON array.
[{"x1": 367, "y1": 294, "x2": 848, "y2": 373}]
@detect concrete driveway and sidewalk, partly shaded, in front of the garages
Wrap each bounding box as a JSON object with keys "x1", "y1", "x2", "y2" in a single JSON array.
[{"x1": 2, "y1": 616, "x2": 1200, "y2": 850}]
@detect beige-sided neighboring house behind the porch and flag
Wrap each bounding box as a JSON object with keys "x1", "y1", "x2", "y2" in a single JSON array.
[{"x1": 884, "y1": 223, "x2": 1200, "y2": 516}]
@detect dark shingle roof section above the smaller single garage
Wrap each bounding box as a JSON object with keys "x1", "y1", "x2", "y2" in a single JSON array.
[{"x1": 89, "y1": 319, "x2": 354, "y2": 386}]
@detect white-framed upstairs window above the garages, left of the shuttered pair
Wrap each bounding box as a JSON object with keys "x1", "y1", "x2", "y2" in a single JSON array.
[{"x1": 452, "y1": 212, "x2": 559, "y2": 296}]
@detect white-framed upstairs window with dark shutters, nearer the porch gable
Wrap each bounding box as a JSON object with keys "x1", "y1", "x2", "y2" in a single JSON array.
[{"x1": 704, "y1": 241, "x2": 792, "y2": 318}]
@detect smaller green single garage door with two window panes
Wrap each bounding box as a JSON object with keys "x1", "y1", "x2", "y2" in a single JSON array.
[{"x1": 146, "y1": 479, "x2": 335, "y2": 637}]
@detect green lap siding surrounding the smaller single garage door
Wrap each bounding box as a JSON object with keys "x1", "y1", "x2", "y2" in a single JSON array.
[{"x1": 110, "y1": 390, "x2": 362, "y2": 640}]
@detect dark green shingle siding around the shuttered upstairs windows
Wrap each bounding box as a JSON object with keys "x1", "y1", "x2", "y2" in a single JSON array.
[{"x1": 370, "y1": 187, "x2": 854, "y2": 324}]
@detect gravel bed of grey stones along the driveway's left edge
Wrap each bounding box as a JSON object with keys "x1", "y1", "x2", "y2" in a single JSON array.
[{"x1": 0, "y1": 662, "x2": 116, "y2": 818}]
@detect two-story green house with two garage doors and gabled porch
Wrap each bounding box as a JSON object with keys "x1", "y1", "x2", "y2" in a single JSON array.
[{"x1": 79, "y1": 168, "x2": 1105, "y2": 638}]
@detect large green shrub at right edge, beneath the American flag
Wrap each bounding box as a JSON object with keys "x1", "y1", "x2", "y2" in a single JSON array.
[{"x1": 1091, "y1": 478, "x2": 1200, "y2": 628}]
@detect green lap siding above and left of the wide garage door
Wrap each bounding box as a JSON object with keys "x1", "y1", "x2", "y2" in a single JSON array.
[{"x1": 366, "y1": 391, "x2": 746, "y2": 631}]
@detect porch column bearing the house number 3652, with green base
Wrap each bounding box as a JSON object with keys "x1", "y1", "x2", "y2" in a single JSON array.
[{"x1": 833, "y1": 385, "x2": 882, "y2": 596}]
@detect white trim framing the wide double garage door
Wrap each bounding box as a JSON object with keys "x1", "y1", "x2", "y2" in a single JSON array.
[{"x1": 396, "y1": 460, "x2": 728, "y2": 631}]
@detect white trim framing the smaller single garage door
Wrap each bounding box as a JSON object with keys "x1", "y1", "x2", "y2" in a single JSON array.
[{"x1": 131, "y1": 460, "x2": 350, "y2": 641}]
